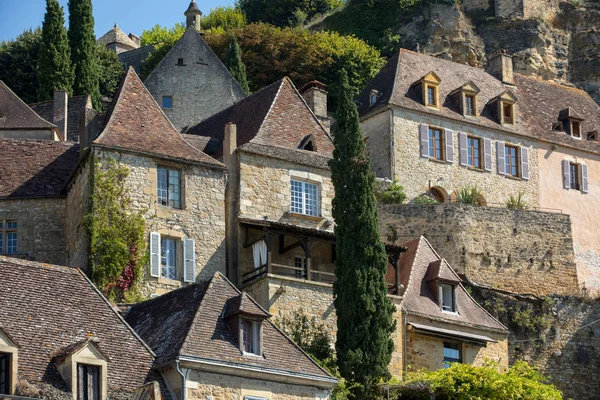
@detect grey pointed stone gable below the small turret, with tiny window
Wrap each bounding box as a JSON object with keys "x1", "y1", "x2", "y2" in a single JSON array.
[{"x1": 144, "y1": 27, "x2": 246, "y2": 131}]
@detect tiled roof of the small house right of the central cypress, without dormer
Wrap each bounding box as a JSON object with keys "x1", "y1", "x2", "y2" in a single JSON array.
[{"x1": 399, "y1": 236, "x2": 508, "y2": 334}]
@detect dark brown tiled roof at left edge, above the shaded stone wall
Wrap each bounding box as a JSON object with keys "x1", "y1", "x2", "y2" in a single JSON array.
[{"x1": 0, "y1": 139, "x2": 79, "y2": 197}]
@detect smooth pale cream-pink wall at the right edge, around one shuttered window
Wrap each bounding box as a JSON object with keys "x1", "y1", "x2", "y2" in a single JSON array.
[{"x1": 538, "y1": 139, "x2": 600, "y2": 291}]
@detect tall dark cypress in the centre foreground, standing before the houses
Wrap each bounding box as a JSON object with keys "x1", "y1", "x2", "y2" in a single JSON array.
[{"x1": 330, "y1": 71, "x2": 396, "y2": 399}]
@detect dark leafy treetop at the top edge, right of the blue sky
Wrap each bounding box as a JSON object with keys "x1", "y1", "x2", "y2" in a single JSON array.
[{"x1": 238, "y1": 0, "x2": 343, "y2": 26}]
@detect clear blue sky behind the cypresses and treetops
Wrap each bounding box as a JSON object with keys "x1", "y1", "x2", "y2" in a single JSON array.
[{"x1": 0, "y1": 0, "x2": 234, "y2": 41}]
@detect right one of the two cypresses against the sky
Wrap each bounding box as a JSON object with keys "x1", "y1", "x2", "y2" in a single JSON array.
[{"x1": 69, "y1": 0, "x2": 101, "y2": 108}]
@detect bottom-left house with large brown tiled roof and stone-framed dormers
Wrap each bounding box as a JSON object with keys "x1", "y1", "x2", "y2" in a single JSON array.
[{"x1": 0, "y1": 256, "x2": 160, "y2": 400}]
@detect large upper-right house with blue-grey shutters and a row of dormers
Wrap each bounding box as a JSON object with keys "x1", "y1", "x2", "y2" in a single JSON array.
[{"x1": 358, "y1": 50, "x2": 600, "y2": 293}]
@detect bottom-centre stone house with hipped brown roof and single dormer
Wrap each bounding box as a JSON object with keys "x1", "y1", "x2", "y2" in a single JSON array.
[{"x1": 125, "y1": 272, "x2": 337, "y2": 400}]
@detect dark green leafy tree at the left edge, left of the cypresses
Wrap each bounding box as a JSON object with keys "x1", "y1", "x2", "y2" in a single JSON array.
[{"x1": 0, "y1": 28, "x2": 42, "y2": 103}]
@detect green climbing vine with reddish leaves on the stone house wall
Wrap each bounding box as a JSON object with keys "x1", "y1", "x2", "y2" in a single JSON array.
[{"x1": 84, "y1": 158, "x2": 148, "y2": 302}]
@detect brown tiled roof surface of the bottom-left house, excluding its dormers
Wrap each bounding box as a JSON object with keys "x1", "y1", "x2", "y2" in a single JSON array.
[{"x1": 0, "y1": 256, "x2": 154, "y2": 394}]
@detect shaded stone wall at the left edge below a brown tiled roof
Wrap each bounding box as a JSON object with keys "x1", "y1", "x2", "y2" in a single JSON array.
[{"x1": 0, "y1": 198, "x2": 67, "y2": 265}]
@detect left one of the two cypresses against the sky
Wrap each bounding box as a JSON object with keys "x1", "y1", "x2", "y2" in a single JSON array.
[{"x1": 37, "y1": 0, "x2": 73, "y2": 101}]
